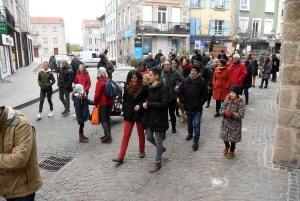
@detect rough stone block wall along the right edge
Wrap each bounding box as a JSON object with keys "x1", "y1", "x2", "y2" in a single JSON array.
[{"x1": 273, "y1": 0, "x2": 300, "y2": 168}]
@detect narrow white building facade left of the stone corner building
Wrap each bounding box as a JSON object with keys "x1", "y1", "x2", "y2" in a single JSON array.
[{"x1": 105, "y1": 0, "x2": 117, "y2": 59}]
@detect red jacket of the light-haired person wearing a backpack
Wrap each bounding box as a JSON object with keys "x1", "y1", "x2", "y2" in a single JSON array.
[{"x1": 94, "y1": 76, "x2": 114, "y2": 106}]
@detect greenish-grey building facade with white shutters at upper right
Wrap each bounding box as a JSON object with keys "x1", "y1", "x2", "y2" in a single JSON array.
[{"x1": 233, "y1": 0, "x2": 281, "y2": 53}]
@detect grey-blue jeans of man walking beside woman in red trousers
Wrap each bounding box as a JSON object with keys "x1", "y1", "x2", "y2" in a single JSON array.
[{"x1": 145, "y1": 127, "x2": 164, "y2": 162}]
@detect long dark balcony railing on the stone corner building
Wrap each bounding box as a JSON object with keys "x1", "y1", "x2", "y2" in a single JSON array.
[{"x1": 136, "y1": 21, "x2": 190, "y2": 35}]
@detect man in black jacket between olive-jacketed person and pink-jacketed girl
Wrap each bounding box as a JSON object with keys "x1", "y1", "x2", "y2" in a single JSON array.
[{"x1": 57, "y1": 59, "x2": 74, "y2": 117}]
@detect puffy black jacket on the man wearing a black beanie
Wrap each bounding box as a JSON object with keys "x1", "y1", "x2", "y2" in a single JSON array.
[{"x1": 178, "y1": 74, "x2": 208, "y2": 114}]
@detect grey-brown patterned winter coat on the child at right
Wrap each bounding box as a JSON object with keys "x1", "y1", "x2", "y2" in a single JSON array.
[{"x1": 219, "y1": 96, "x2": 245, "y2": 142}]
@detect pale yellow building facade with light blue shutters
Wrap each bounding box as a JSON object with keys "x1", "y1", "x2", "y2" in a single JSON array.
[{"x1": 190, "y1": 0, "x2": 234, "y2": 52}]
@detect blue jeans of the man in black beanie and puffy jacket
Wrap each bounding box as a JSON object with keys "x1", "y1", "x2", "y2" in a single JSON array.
[{"x1": 187, "y1": 112, "x2": 202, "y2": 142}]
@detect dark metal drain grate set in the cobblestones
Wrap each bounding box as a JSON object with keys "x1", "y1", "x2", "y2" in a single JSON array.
[{"x1": 39, "y1": 156, "x2": 73, "y2": 172}]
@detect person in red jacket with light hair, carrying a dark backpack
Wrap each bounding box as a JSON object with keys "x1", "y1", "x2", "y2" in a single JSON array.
[{"x1": 94, "y1": 67, "x2": 114, "y2": 143}]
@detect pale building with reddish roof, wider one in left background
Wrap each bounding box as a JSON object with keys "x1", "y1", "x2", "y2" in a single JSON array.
[{"x1": 30, "y1": 17, "x2": 67, "y2": 61}]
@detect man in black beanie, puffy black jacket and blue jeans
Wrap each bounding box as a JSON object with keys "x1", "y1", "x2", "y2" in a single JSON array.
[{"x1": 179, "y1": 65, "x2": 208, "y2": 151}]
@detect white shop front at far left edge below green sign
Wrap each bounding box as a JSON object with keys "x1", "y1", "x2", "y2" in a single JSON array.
[{"x1": 0, "y1": 34, "x2": 14, "y2": 79}]
